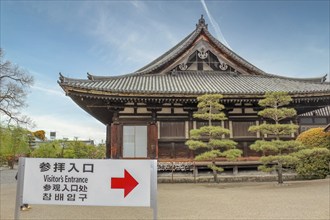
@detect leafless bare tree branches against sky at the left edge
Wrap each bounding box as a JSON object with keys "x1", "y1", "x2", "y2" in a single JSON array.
[{"x1": 0, "y1": 48, "x2": 33, "y2": 124}]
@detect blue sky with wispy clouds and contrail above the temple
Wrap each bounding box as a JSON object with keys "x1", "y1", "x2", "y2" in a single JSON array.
[{"x1": 0, "y1": 0, "x2": 330, "y2": 142}]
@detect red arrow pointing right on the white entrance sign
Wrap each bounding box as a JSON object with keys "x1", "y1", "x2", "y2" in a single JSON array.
[{"x1": 111, "y1": 169, "x2": 139, "y2": 198}]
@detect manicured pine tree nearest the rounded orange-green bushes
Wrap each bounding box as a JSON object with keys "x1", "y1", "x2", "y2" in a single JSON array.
[{"x1": 249, "y1": 92, "x2": 302, "y2": 184}]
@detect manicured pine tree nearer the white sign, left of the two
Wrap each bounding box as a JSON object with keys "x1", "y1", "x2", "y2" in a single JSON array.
[{"x1": 186, "y1": 94, "x2": 242, "y2": 182}]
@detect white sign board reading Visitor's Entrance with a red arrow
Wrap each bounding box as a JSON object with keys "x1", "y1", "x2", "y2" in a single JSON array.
[{"x1": 22, "y1": 158, "x2": 155, "y2": 207}]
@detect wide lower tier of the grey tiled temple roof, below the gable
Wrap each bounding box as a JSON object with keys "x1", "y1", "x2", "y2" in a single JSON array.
[{"x1": 59, "y1": 71, "x2": 330, "y2": 96}]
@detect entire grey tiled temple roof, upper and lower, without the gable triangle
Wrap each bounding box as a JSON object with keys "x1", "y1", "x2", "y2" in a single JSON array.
[{"x1": 59, "y1": 17, "x2": 330, "y2": 99}]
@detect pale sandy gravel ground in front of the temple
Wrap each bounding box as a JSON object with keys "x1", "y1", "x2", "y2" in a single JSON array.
[{"x1": 0, "y1": 170, "x2": 330, "y2": 220}]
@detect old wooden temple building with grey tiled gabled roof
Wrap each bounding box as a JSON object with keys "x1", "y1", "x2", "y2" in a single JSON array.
[{"x1": 59, "y1": 16, "x2": 330, "y2": 167}]
